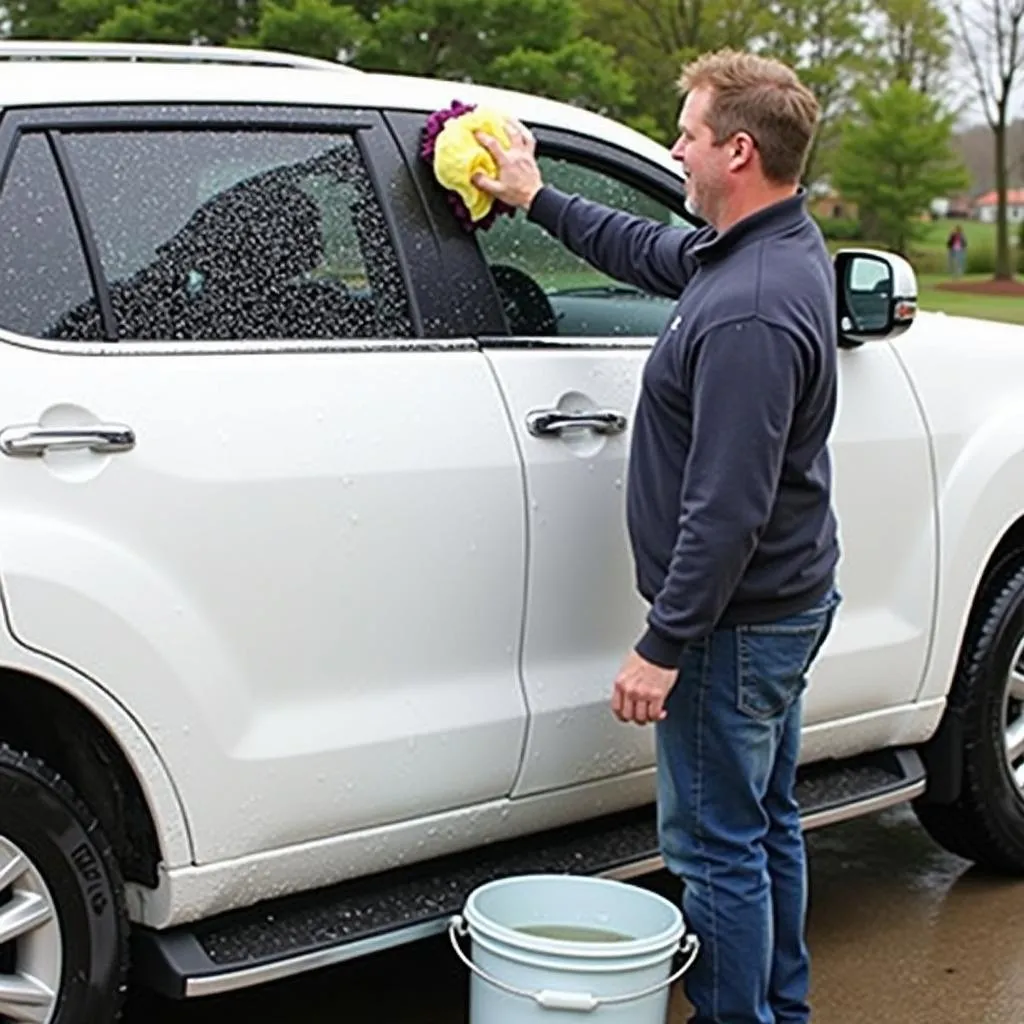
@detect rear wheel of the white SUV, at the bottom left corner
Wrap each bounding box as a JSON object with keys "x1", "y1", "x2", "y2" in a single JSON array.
[{"x1": 0, "y1": 744, "x2": 128, "y2": 1024}]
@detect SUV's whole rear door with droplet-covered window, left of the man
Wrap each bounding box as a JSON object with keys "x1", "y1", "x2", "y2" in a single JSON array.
[{"x1": 0, "y1": 106, "x2": 525, "y2": 863}]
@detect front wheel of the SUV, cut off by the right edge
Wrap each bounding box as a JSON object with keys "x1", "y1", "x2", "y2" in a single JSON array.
[{"x1": 914, "y1": 556, "x2": 1024, "y2": 874}]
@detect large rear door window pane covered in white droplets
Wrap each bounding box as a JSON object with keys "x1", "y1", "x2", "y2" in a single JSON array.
[{"x1": 56, "y1": 129, "x2": 413, "y2": 341}]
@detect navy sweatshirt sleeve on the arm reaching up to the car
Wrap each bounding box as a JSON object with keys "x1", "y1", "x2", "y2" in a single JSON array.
[{"x1": 527, "y1": 185, "x2": 707, "y2": 299}]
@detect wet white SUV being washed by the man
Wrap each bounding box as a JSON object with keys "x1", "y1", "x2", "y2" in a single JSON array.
[{"x1": 0, "y1": 37, "x2": 1024, "y2": 1024}]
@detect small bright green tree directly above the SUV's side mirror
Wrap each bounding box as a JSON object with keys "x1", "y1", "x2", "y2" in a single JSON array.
[{"x1": 834, "y1": 82, "x2": 968, "y2": 256}]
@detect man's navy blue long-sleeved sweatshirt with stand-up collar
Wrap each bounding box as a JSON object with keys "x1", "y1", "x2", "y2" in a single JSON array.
[{"x1": 528, "y1": 186, "x2": 839, "y2": 668}]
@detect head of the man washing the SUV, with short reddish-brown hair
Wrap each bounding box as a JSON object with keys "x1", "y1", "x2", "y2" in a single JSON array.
[{"x1": 672, "y1": 50, "x2": 820, "y2": 226}]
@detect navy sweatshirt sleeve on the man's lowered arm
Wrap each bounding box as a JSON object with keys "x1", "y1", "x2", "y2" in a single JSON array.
[{"x1": 636, "y1": 318, "x2": 804, "y2": 668}]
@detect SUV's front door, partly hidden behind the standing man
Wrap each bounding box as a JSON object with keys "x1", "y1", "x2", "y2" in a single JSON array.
[{"x1": 393, "y1": 119, "x2": 935, "y2": 797}]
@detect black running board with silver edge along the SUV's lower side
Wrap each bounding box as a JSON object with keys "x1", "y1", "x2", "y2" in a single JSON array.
[{"x1": 133, "y1": 750, "x2": 926, "y2": 998}]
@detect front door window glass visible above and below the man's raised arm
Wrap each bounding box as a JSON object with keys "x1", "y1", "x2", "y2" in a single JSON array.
[{"x1": 477, "y1": 156, "x2": 692, "y2": 337}]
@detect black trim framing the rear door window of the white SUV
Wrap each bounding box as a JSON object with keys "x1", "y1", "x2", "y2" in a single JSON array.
[{"x1": 0, "y1": 102, "x2": 454, "y2": 353}]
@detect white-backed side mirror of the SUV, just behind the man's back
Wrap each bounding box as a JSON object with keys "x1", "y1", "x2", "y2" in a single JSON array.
[{"x1": 833, "y1": 249, "x2": 918, "y2": 347}]
